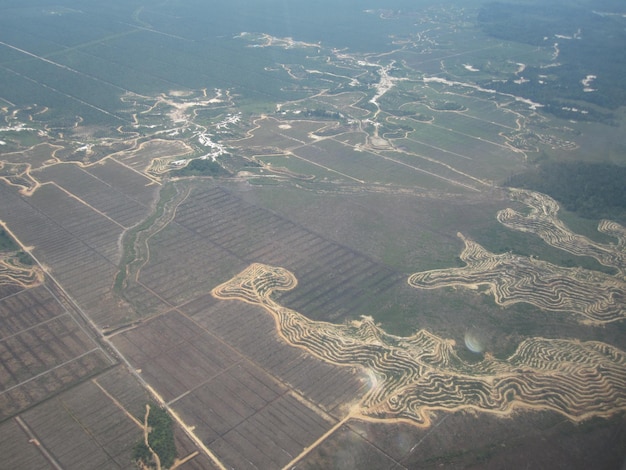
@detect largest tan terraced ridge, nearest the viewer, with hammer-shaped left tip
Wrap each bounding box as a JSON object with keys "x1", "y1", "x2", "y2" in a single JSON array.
[{"x1": 212, "y1": 264, "x2": 626, "y2": 427}]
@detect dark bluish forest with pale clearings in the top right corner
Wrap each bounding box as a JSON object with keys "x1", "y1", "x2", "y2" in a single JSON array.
[{"x1": 478, "y1": 2, "x2": 626, "y2": 123}]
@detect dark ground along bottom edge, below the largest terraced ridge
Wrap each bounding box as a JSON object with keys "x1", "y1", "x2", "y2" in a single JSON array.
[{"x1": 326, "y1": 412, "x2": 626, "y2": 470}]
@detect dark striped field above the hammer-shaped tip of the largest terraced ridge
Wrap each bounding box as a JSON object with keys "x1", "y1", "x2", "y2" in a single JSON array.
[{"x1": 117, "y1": 187, "x2": 399, "y2": 326}]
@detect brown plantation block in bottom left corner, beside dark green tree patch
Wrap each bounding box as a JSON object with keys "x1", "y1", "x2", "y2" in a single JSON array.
[{"x1": 0, "y1": 367, "x2": 214, "y2": 469}]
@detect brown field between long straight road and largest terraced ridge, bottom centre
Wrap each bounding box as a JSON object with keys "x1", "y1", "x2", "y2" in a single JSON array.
[{"x1": 112, "y1": 302, "x2": 365, "y2": 468}]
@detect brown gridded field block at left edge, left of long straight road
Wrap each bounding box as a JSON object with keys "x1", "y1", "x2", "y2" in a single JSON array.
[{"x1": 0, "y1": 286, "x2": 111, "y2": 420}]
